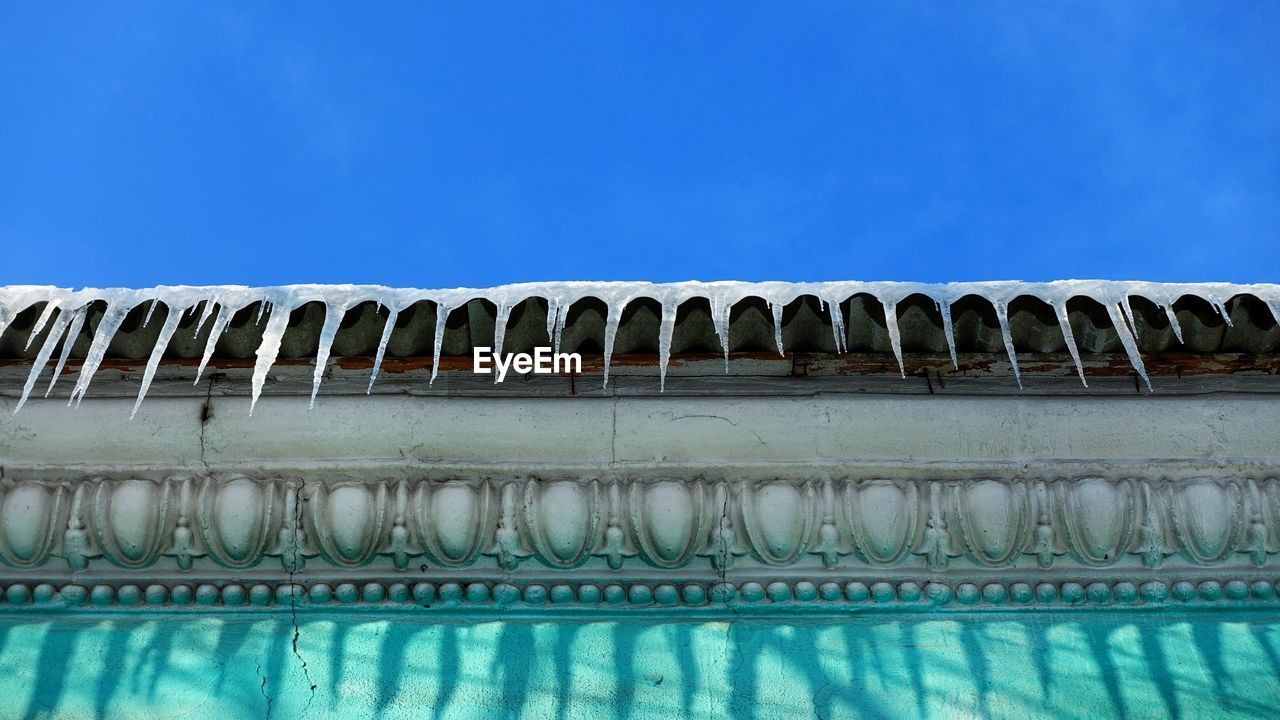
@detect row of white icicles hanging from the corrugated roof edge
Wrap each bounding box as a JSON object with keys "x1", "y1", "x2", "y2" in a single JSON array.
[{"x1": 0, "y1": 281, "x2": 1280, "y2": 418}]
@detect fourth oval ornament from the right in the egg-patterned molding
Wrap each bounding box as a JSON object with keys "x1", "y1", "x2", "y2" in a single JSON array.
[{"x1": 844, "y1": 480, "x2": 920, "y2": 565}]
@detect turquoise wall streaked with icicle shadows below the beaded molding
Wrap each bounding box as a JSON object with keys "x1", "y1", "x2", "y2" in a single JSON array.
[{"x1": 0, "y1": 612, "x2": 1280, "y2": 720}]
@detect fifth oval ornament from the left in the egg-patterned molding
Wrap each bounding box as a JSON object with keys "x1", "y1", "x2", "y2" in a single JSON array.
[{"x1": 413, "y1": 482, "x2": 494, "y2": 568}]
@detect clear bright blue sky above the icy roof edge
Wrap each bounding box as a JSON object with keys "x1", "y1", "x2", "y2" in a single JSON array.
[{"x1": 0, "y1": 0, "x2": 1280, "y2": 287}]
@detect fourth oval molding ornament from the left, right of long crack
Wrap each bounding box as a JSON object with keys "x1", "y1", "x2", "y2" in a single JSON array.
[{"x1": 307, "y1": 483, "x2": 387, "y2": 568}]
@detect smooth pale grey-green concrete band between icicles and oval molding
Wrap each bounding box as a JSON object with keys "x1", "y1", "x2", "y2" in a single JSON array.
[{"x1": 0, "y1": 393, "x2": 1280, "y2": 471}]
